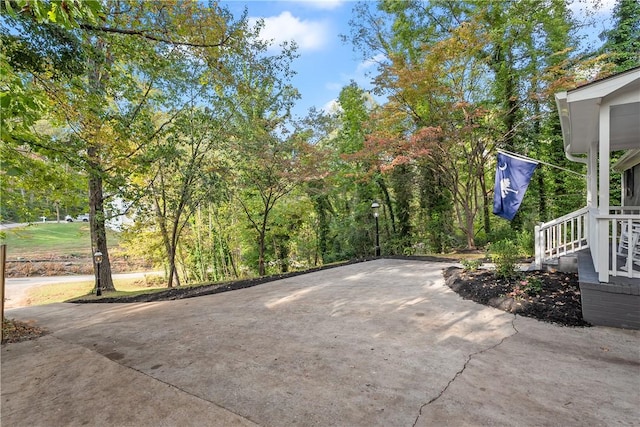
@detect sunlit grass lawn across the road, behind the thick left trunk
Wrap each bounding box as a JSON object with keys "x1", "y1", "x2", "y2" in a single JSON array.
[{"x1": 2, "y1": 222, "x2": 117, "y2": 259}]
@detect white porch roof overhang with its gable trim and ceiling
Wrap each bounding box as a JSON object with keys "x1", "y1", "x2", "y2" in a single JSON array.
[{"x1": 556, "y1": 68, "x2": 640, "y2": 154}]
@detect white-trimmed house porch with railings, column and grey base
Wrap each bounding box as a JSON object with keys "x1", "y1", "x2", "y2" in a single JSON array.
[{"x1": 535, "y1": 67, "x2": 640, "y2": 329}]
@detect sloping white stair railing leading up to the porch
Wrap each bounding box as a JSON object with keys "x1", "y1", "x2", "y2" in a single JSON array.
[{"x1": 535, "y1": 208, "x2": 589, "y2": 268}]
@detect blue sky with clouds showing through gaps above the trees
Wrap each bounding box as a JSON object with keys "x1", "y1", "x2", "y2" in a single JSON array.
[{"x1": 221, "y1": 0, "x2": 615, "y2": 117}]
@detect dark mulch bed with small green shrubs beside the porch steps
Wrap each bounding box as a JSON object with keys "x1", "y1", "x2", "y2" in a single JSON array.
[{"x1": 444, "y1": 267, "x2": 590, "y2": 326}]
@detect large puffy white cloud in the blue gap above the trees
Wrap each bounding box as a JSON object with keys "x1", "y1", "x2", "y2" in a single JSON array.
[{"x1": 250, "y1": 11, "x2": 331, "y2": 51}]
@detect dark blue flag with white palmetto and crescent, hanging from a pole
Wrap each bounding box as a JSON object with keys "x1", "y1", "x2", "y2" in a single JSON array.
[{"x1": 493, "y1": 153, "x2": 538, "y2": 221}]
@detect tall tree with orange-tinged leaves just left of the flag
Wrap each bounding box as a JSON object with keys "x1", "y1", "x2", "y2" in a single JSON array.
[{"x1": 344, "y1": 0, "x2": 575, "y2": 247}]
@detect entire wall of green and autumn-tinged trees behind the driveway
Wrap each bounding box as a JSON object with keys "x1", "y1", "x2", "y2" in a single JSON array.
[{"x1": 0, "y1": 0, "x2": 640, "y2": 289}]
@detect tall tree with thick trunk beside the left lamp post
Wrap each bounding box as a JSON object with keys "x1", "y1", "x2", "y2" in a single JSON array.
[{"x1": 3, "y1": 1, "x2": 241, "y2": 289}]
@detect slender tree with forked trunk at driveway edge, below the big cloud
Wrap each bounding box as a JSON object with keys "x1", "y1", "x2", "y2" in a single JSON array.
[{"x1": 229, "y1": 36, "x2": 306, "y2": 276}]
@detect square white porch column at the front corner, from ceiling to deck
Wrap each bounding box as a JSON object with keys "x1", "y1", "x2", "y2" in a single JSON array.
[{"x1": 596, "y1": 103, "x2": 611, "y2": 282}]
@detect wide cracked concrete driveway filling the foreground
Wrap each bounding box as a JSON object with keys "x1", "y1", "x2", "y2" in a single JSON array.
[{"x1": 1, "y1": 259, "x2": 640, "y2": 426}]
